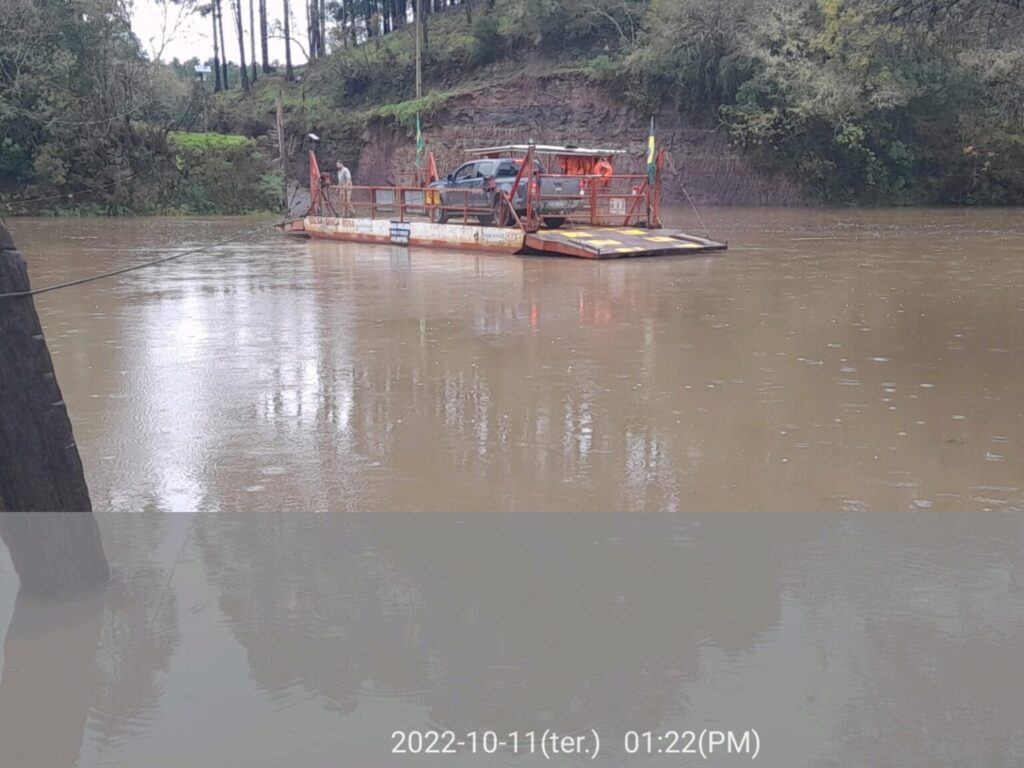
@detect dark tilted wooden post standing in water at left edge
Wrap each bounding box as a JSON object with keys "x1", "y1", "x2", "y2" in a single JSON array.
[{"x1": 0, "y1": 224, "x2": 110, "y2": 596}]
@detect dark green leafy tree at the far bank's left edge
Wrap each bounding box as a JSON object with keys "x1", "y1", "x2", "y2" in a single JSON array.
[{"x1": 0, "y1": 0, "x2": 172, "y2": 197}]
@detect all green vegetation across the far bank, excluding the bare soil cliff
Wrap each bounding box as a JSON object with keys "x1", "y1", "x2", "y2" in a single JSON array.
[{"x1": 0, "y1": 0, "x2": 1024, "y2": 213}]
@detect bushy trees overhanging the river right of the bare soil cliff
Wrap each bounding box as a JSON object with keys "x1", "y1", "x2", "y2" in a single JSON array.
[{"x1": 614, "y1": 0, "x2": 1024, "y2": 204}]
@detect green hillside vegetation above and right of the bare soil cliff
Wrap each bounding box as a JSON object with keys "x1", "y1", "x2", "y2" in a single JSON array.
[{"x1": 307, "y1": 0, "x2": 1024, "y2": 205}]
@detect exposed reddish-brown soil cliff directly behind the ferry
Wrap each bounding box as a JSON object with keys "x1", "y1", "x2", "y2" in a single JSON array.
[{"x1": 356, "y1": 75, "x2": 804, "y2": 206}]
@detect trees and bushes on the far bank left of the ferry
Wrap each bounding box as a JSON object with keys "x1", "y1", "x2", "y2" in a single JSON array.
[{"x1": 0, "y1": 0, "x2": 283, "y2": 215}]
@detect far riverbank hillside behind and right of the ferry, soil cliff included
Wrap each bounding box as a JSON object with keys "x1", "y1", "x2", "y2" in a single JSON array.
[{"x1": 224, "y1": 0, "x2": 1024, "y2": 206}]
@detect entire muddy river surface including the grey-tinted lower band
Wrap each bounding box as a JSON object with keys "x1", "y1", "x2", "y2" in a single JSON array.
[{"x1": 0, "y1": 210, "x2": 1024, "y2": 768}]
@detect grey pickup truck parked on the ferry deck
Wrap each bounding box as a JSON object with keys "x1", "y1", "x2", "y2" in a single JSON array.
[{"x1": 430, "y1": 158, "x2": 584, "y2": 229}]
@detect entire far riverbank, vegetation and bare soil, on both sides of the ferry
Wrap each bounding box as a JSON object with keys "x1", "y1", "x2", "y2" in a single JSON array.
[{"x1": 8, "y1": 0, "x2": 1024, "y2": 215}]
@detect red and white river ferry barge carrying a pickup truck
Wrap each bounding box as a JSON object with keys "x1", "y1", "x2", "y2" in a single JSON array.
[{"x1": 278, "y1": 144, "x2": 726, "y2": 259}]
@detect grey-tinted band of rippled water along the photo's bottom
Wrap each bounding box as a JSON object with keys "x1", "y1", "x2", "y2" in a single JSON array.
[{"x1": 0, "y1": 512, "x2": 1024, "y2": 768}]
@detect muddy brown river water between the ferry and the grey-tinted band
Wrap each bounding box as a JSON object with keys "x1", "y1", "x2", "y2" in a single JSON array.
[{"x1": 4, "y1": 209, "x2": 1024, "y2": 511}]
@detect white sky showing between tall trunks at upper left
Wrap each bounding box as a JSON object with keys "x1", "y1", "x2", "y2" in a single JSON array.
[{"x1": 131, "y1": 0, "x2": 308, "y2": 66}]
